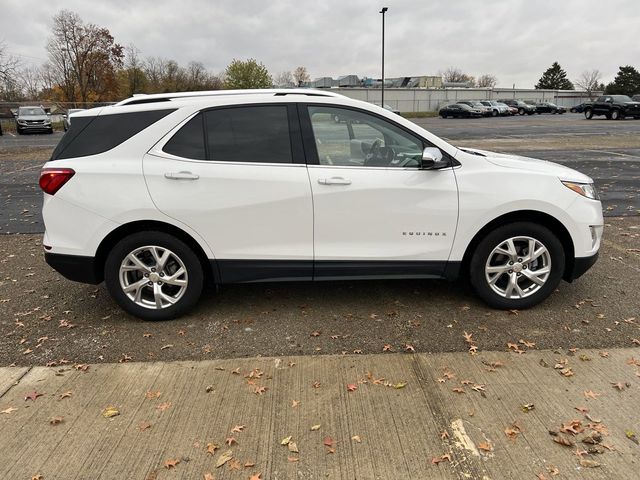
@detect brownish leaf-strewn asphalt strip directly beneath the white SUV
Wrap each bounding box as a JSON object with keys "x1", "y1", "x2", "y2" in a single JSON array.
[{"x1": 0, "y1": 217, "x2": 640, "y2": 366}]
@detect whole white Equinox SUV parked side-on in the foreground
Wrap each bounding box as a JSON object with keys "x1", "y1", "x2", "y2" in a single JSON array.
[{"x1": 40, "y1": 90, "x2": 603, "y2": 320}]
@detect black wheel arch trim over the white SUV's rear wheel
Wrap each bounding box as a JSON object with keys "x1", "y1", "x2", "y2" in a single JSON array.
[{"x1": 95, "y1": 220, "x2": 220, "y2": 283}]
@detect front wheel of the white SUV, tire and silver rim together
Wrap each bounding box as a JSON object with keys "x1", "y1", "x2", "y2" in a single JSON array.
[{"x1": 469, "y1": 222, "x2": 565, "y2": 310}]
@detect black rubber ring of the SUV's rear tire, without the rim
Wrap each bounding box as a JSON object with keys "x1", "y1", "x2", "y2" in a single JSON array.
[{"x1": 104, "y1": 231, "x2": 204, "y2": 321}]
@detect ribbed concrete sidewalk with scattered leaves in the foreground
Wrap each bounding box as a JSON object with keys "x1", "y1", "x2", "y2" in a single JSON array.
[{"x1": 0, "y1": 345, "x2": 640, "y2": 480}]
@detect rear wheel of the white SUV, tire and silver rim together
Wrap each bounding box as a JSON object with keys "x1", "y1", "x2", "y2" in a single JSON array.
[{"x1": 104, "y1": 231, "x2": 204, "y2": 320}]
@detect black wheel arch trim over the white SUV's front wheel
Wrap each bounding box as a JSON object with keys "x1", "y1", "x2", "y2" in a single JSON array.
[{"x1": 460, "y1": 210, "x2": 575, "y2": 280}]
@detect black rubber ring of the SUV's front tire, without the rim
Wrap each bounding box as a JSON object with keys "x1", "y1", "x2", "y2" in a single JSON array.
[{"x1": 469, "y1": 222, "x2": 565, "y2": 310}]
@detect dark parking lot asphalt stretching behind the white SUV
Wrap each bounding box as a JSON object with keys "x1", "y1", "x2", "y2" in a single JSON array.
[{"x1": 0, "y1": 114, "x2": 640, "y2": 234}]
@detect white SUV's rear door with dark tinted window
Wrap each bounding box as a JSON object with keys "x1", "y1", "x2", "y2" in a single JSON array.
[{"x1": 144, "y1": 104, "x2": 313, "y2": 283}]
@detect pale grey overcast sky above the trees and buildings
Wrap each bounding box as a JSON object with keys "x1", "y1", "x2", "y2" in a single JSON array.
[{"x1": 0, "y1": 0, "x2": 640, "y2": 88}]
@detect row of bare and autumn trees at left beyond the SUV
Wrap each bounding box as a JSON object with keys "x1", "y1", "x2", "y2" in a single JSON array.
[{"x1": 0, "y1": 10, "x2": 309, "y2": 106}]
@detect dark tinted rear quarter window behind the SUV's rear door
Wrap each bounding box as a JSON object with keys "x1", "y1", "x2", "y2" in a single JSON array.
[{"x1": 51, "y1": 109, "x2": 175, "y2": 160}]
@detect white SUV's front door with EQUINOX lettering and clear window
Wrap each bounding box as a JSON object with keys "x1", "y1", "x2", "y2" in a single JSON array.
[{"x1": 301, "y1": 105, "x2": 458, "y2": 278}]
